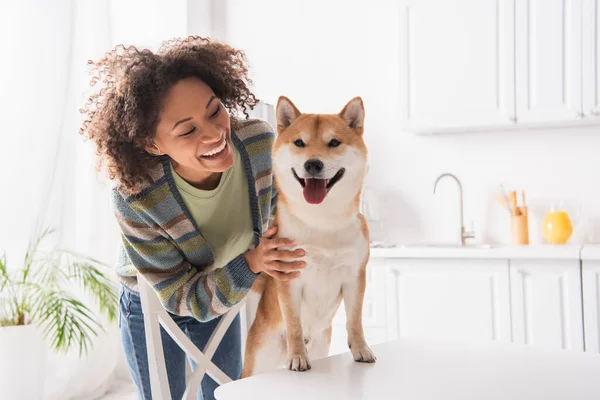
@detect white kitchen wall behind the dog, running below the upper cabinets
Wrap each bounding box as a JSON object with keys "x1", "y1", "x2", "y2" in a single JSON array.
[{"x1": 226, "y1": 0, "x2": 600, "y2": 243}]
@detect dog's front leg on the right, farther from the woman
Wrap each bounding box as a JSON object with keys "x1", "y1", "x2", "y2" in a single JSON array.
[{"x1": 342, "y1": 266, "x2": 377, "y2": 363}]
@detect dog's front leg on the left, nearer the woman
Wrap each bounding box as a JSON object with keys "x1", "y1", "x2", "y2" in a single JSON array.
[{"x1": 278, "y1": 281, "x2": 310, "y2": 371}]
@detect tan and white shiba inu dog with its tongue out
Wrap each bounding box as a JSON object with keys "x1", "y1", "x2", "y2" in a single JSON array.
[{"x1": 242, "y1": 97, "x2": 376, "y2": 377}]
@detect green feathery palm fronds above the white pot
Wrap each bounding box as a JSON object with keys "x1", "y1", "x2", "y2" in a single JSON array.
[{"x1": 0, "y1": 225, "x2": 118, "y2": 356}]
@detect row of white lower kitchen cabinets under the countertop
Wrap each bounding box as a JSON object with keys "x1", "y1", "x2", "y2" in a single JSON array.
[{"x1": 330, "y1": 252, "x2": 588, "y2": 354}]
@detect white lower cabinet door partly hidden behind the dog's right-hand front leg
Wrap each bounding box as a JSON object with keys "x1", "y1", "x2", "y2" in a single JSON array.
[{"x1": 329, "y1": 258, "x2": 389, "y2": 355}]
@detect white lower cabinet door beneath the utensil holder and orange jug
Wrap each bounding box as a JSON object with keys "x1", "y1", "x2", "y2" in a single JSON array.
[{"x1": 510, "y1": 260, "x2": 583, "y2": 350}]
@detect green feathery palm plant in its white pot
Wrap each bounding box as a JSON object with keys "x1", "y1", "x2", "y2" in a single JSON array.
[{"x1": 0, "y1": 230, "x2": 118, "y2": 399}]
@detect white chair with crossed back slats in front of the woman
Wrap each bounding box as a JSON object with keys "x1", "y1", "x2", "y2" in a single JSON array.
[{"x1": 138, "y1": 276, "x2": 244, "y2": 400}]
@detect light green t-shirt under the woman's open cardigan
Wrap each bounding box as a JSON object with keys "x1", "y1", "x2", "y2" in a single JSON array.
[{"x1": 171, "y1": 146, "x2": 254, "y2": 268}]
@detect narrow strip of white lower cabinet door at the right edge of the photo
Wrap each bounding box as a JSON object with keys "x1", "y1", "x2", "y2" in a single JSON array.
[{"x1": 582, "y1": 260, "x2": 600, "y2": 353}]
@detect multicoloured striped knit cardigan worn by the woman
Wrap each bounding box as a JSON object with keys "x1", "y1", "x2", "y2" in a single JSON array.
[{"x1": 112, "y1": 119, "x2": 277, "y2": 321}]
